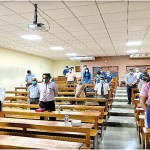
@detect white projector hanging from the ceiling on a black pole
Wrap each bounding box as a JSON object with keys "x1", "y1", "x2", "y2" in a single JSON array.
[{"x1": 28, "y1": 4, "x2": 45, "y2": 31}]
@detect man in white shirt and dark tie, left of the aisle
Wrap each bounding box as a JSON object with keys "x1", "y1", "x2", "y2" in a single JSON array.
[{"x1": 94, "y1": 75, "x2": 110, "y2": 105}]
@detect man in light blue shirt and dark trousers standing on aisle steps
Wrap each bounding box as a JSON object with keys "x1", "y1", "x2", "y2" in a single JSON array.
[{"x1": 125, "y1": 68, "x2": 137, "y2": 104}]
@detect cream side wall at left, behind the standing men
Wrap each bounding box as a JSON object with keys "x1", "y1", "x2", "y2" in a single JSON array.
[{"x1": 0, "y1": 48, "x2": 53, "y2": 90}]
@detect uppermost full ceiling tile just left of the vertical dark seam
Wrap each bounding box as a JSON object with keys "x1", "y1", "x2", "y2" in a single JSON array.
[{"x1": 98, "y1": 2, "x2": 127, "y2": 14}]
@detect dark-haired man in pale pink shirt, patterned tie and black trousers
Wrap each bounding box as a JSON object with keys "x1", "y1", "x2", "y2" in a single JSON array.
[{"x1": 39, "y1": 73, "x2": 58, "y2": 121}]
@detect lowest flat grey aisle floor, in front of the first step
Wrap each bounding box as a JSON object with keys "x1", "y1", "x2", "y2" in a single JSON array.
[{"x1": 99, "y1": 127, "x2": 140, "y2": 150}]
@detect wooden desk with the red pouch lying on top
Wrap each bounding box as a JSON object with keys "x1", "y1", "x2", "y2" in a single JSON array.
[{"x1": 1, "y1": 108, "x2": 100, "y2": 129}]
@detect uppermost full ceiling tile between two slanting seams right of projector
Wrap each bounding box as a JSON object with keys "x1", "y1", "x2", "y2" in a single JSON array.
[{"x1": 70, "y1": 5, "x2": 99, "y2": 17}]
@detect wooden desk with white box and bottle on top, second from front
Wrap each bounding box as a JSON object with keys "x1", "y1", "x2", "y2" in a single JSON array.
[{"x1": 0, "y1": 118, "x2": 92, "y2": 148}]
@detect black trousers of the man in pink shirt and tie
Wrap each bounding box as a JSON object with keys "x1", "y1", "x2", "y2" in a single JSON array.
[{"x1": 39, "y1": 100, "x2": 56, "y2": 121}]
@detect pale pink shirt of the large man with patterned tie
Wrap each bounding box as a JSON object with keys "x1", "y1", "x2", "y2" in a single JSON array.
[{"x1": 39, "y1": 82, "x2": 58, "y2": 101}]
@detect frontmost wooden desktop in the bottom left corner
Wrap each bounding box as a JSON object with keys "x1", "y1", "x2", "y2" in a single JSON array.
[{"x1": 0, "y1": 135, "x2": 82, "y2": 150}]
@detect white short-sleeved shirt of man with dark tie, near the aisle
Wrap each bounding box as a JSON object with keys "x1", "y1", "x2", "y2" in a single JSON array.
[{"x1": 94, "y1": 82, "x2": 110, "y2": 95}]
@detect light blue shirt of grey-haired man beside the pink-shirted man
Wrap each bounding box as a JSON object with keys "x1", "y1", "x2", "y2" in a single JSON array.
[{"x1": 28, "y1": 84, "x2": 40, "y2": 98}]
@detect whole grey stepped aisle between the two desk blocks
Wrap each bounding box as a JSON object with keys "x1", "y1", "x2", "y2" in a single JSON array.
[{"x1": 99, "y1": 87, "x2": 141, "y2": 150}]
